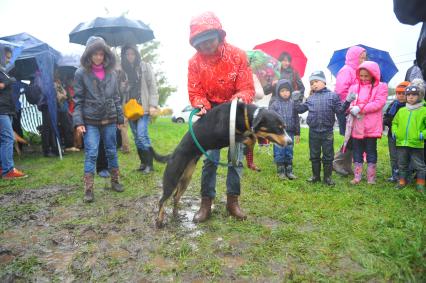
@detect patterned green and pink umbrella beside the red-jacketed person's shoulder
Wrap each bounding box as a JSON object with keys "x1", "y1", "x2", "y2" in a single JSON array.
[{"x1": 246, "y1": 50, "x2": 281, "y2": 94}]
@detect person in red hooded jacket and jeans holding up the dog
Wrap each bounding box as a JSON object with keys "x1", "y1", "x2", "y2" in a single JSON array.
[{"x1": 188, "y1": 12, "x2": 255, "y2": 222}]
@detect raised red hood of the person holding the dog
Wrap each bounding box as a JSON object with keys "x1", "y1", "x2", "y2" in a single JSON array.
[{"x1": 189, "y1": 12, "x2": 226, "y2": 46}]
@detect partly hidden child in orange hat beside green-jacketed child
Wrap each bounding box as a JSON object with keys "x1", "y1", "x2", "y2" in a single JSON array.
[{"x1": 383, "y1": 81, "x2": 410, "y2": 183}]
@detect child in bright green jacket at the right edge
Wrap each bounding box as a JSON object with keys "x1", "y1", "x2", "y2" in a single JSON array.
[{"x1": 392, "y1": 79, "x2": 426, "y2": 192}]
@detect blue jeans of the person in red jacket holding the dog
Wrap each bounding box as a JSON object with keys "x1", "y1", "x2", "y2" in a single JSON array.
[{"x1": 201, "y1": 143, "x2": 244, "y2": 198}]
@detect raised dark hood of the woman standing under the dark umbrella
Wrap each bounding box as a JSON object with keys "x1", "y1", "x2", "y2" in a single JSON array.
[{"x1": 80, "y1": 36, "x2": 115, "y2": 71}]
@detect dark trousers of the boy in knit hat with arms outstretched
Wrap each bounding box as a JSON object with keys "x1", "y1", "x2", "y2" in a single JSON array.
[{"x1": 309, "y1": 130, "x2": 334, "y2": 165}]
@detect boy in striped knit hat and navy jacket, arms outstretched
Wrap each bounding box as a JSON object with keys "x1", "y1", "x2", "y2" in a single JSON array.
[{"x1": 293, "y1": 71, "x2": 356, "y2": 186}]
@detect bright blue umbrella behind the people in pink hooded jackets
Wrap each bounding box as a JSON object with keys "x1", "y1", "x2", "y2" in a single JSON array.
[{"x1": 327, "y1": 44, "x2": 398, "y2": 83}]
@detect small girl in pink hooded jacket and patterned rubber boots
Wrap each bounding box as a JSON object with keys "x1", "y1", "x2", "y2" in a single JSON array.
[{"x1": 349, "y1": 61, "x2": 388, "y2": 184}]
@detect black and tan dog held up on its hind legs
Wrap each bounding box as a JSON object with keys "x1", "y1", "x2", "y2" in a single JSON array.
[{"x1": 153, "y1": 102, "x2": 292, "y2": 228}]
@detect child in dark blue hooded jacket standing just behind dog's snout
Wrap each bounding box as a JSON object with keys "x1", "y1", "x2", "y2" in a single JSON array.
[{"x1": 269, "y1": 79, "x2": 300, "y2": 180}]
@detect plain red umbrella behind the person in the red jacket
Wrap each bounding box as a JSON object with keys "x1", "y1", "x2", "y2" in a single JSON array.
[{"x1": 254, "y1": 39, "x2": 308, "y2": 77}]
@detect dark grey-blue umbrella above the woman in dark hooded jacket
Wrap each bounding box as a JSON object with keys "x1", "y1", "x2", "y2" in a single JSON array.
[{"x1": 69, "y1": 16, "x2": 154, "y2": 47}]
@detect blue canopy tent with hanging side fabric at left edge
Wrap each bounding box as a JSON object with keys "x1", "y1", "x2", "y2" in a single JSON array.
[{"x1": 0, "y1": 33, "x2": 61, "y2": 158}]
